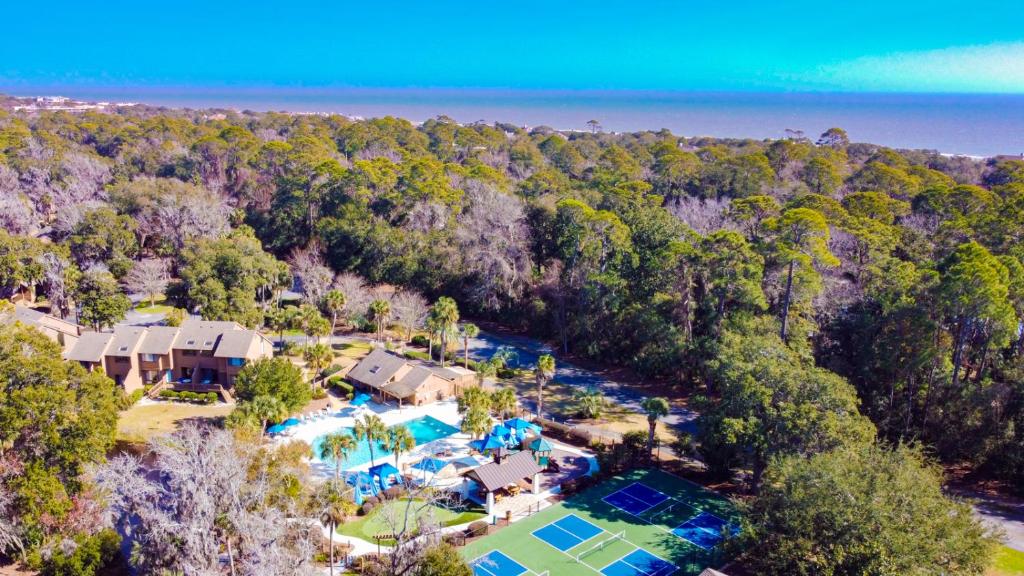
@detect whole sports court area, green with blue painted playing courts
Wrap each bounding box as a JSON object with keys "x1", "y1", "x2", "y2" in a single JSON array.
[{"x1": 463, "y1": 470, "x2": 739, "y2": 576}]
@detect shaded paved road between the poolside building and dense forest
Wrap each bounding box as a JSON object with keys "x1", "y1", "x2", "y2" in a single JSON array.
[{"x1": 469, "y1": 330, "x2": 697, "y2": 434}]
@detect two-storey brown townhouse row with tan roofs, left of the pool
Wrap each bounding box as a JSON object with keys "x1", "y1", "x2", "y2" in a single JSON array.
[{"x1": 65, "y1": 320, "x2": 273, "y2": 393}]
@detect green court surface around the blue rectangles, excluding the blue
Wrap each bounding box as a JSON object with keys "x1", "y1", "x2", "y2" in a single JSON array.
[{"x1": 462, "y1": 470, "x2": 739, "y2": 576}]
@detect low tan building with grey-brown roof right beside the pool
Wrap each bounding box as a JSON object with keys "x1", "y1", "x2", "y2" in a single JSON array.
[{"x1": 347, "y1": 348, "x2": 476, "y2": 406}]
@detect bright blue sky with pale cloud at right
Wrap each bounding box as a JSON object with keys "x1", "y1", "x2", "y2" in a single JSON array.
[{"x1": 0, "y1": 0, "x2": 1024, "y2": 93}]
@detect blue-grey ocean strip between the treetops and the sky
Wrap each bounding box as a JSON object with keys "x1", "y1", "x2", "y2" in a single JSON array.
[{"x1": 9, "y1": 86, "x2": 1024, "y2": 156}]
